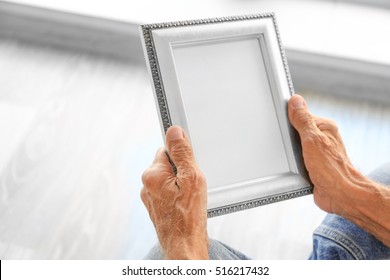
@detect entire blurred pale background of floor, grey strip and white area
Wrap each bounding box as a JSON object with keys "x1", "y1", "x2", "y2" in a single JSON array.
[{"x1": 0, "y1": 0, "x2": 390, "y2": 259}]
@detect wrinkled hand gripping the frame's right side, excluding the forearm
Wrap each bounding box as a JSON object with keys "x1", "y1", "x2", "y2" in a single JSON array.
[{"x1": 288, "y1": 95, "x2": 361, "y2": 214}]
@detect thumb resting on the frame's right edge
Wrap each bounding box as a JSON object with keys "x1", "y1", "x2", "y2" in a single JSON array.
[{"x1": 288, "y1": 95, "x2": 317, "y2": 138}]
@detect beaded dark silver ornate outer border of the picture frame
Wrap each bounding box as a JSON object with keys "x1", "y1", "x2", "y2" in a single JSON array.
[{"x1": 140, "y1": 13, "x2": 313, "y2": 218}]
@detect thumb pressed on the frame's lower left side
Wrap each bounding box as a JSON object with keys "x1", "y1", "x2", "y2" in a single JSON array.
[{"x1": 166, "y1": 126, "x2": 195, "y2": 173}]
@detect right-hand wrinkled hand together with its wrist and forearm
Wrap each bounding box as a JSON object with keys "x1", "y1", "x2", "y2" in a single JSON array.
[{"x1": 288, "y1": 95, "x2": 390, "y2": 246}]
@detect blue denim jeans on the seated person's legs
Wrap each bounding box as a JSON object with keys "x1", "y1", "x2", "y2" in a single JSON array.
[{"x1": 146, "y1": 164, "x2": 390, "y2": 260}]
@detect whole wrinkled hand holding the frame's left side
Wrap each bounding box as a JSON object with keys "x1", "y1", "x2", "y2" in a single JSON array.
[{"x1": 141, "y1": 126, "x2": 208, "y2": 259}]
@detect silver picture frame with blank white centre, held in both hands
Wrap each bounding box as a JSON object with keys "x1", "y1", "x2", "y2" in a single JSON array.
[{"x1": 140, "y1": 13, "x2": 312, "y2": 217}]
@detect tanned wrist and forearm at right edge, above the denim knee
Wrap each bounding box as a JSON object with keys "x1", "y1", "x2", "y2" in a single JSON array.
[{"x1": 337, "y1": 166, "x2": 390, "y2": 247}]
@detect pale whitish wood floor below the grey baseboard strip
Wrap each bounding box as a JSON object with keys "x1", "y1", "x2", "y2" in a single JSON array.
[{"x1": 0, "y1": 40, "x2": 390, "y2": 259}]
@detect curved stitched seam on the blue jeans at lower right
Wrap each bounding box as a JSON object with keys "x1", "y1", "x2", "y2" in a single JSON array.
[{"x1": 314, "y1": 225, "x2": 365, "y2": 260}]
